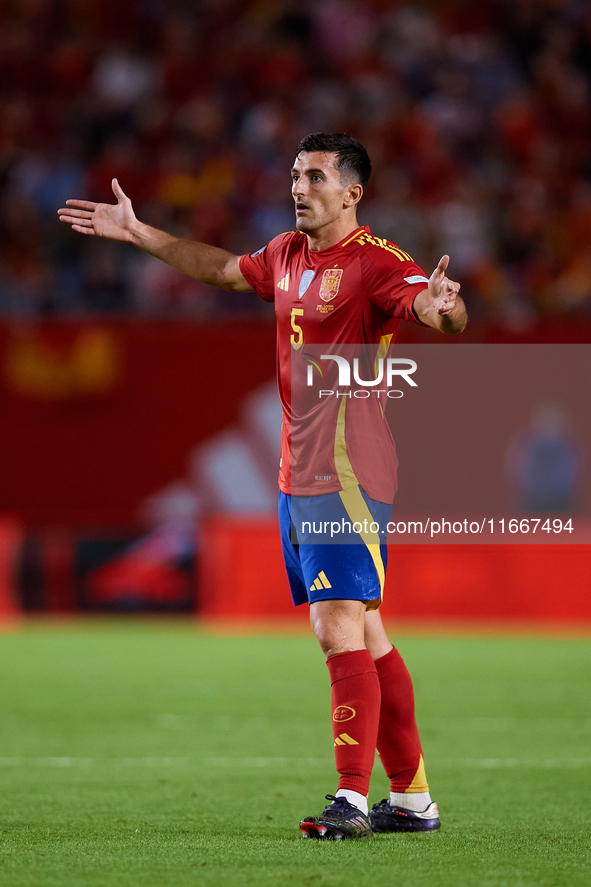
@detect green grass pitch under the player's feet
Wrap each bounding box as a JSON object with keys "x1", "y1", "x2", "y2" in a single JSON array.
[{"x1": 0, "y1": 620, "x2": 591, "y2": 887}]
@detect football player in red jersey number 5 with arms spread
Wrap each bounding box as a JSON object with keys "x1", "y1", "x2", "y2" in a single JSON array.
[{"x1": 59, "y1": 133, "x2": 467, "y2": 839}]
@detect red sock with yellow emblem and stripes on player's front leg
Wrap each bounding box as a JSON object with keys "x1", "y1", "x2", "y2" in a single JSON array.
[{"x1": 326, "y1": 650, "x2": 380, "y2": 796}]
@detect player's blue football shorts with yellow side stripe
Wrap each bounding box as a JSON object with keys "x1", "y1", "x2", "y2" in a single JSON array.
[{"x1": 279, "y1": 486, "x2": 392, "y2": 610}]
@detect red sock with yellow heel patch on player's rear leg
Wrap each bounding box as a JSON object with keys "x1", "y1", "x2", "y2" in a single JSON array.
[{"x1": 375, "y1": 648, "x2": 429, "y2": 792}]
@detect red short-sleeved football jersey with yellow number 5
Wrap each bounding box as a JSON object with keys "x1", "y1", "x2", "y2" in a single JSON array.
[{"x1": 240, "y1": 226, "x2": 428, "y2": 502}]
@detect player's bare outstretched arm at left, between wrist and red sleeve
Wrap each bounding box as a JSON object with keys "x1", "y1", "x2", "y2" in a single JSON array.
[{"x1": 131, "y1": 221, "x2": 236, "y2": 289}]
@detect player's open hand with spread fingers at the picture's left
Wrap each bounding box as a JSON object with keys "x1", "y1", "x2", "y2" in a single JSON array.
[{"x1": 58, "y1": 179, "x2": 137, "y2": 242}]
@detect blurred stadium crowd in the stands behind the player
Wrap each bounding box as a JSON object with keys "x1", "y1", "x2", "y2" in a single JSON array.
[{"x1": 0, "y1": 0, "x2": 591, "y2": 325}]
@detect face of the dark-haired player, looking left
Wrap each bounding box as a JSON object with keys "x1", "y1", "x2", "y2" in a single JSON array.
[{"x1": 291, "y1": 151, "x2": 350, "y2": 234}]
